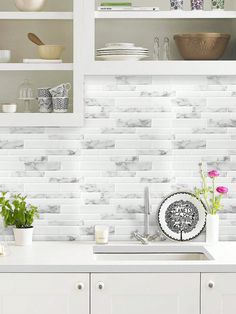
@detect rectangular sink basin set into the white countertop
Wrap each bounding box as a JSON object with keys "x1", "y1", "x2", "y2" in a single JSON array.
[{"x1": 93, "y1": 245, "x2": 213, "y2": 261}]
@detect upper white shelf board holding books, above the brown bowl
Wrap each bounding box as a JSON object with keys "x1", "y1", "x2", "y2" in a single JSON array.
[{"x1": 95, "y1": 10, "x2": 236, "y2": 19}]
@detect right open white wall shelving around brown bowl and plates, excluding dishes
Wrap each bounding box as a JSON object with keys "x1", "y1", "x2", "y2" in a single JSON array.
[{"x1": 78, "y1": 0, "x2": 236, "y2": 75}]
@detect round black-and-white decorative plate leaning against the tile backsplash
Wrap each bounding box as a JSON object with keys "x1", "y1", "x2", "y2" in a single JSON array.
[{"x1": 157, "y1": 192, "x2": 206, "y2": 241}]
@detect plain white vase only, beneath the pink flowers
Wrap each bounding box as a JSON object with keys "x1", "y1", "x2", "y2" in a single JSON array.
[{"x1": 206, "y1": 214, "x2": 220, "y2": 244}]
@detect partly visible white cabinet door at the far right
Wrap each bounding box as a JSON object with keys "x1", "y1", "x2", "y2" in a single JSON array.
[{"x1": 201, "y1": 273, "x2": 236, "y2": 314}]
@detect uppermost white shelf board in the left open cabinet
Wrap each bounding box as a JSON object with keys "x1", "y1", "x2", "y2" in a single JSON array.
[{"x1": 0, "y1": 12, "x2": 73, "y2": 20}]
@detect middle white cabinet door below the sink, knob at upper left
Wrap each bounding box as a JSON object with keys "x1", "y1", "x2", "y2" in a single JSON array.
[{"x1": 91, "y1": 274, "x2": 200, "y2": 314}]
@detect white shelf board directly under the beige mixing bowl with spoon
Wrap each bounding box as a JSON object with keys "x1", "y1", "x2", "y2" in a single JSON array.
[{"x1": 0, "y1": 63, "x2": 73, "y2": 71}]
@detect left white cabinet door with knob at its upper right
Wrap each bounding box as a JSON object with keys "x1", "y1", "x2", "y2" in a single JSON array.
[{"x1": 0, "y1": 274, "x2": 89, "y2": 314}]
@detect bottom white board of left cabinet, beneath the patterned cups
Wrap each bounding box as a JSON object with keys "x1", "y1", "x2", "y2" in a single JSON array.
[{"x1": 0, "y1": 113, "x2": 83, "y2": 127}]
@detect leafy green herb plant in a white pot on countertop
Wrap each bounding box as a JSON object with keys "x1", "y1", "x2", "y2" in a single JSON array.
[{"x1": 0, "y1": 192, "x2": 39, "y2": 245}]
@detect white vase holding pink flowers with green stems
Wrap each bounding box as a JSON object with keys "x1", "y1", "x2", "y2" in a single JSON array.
[{"x1": 195, "y1": 164, "x2": 228, "y2": 243}]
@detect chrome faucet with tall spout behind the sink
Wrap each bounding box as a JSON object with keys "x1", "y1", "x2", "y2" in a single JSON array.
[{"x1": 131, "y1": 186, "x2": 165, "y2": 244}]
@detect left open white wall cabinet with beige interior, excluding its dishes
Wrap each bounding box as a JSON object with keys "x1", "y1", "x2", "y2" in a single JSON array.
[{"x1": 0, "y1": 0, "x2": 84, "y2": 127}]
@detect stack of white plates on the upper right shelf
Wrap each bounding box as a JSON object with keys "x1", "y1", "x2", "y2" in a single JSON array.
[{"x1": 97, "y1": 43, "x2": 148, "y2": 61}]
